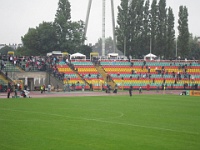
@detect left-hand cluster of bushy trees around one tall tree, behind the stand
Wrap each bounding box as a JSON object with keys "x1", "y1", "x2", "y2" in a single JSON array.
[{"x1": 16, "y1": 0, "x2": 92, "y2": 56}]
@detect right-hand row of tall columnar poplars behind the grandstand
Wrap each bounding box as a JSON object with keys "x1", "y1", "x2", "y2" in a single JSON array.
[{"x1": 116, "y1": 0, "x2": 200, "y2": 59}]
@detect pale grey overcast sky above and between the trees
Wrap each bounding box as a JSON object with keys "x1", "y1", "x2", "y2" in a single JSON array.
[{"x1": 0, "y1": 0, "x2": 200, "y2": 44}]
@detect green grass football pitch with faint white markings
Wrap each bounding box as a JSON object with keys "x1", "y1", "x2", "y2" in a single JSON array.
[{"x1": 0, "y1": 95, "x2": 200, "y2": 150}]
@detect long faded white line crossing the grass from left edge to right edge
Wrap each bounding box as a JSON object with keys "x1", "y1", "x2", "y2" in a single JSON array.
[{"x1": 1, "y1": 109, "x2": 199, "y2": 135}]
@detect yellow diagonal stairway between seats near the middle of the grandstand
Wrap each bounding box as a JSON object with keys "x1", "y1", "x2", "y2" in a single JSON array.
[{"x1": 95, "y1": 64, "x2": 116, "y2": 89}]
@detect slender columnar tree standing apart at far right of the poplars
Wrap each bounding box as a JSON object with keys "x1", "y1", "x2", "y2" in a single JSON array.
[{"x1": 178, "y1": 6, "x2": 189, "y2": 58}]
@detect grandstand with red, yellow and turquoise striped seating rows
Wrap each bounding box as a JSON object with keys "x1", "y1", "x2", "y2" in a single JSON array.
[{"x1": 0, "y1": 53, "x2": 200, "y2": 91}]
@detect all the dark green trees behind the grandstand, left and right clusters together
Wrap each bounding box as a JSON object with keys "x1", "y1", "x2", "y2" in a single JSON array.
[{"x1": 1, "y1": 0, "x2": 200, "y2": 59}]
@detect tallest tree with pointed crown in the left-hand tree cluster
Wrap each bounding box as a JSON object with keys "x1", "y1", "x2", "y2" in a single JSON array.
[{"x1": 54, "y1": 0, "x2": 85, "y2": 53}]
